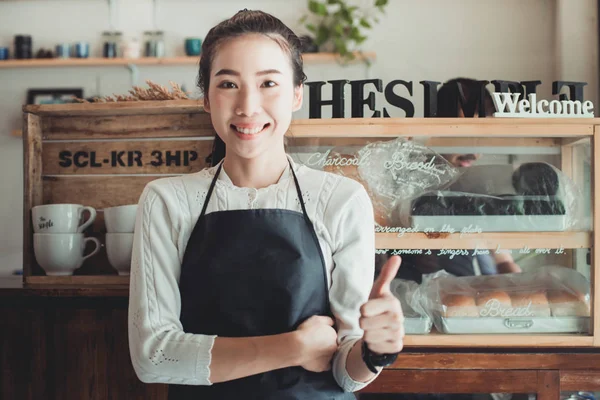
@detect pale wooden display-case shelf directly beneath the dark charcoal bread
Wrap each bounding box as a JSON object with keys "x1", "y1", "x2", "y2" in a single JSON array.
[{"x1": 375, "y1": 232, "x2": 592, "y2": 249}]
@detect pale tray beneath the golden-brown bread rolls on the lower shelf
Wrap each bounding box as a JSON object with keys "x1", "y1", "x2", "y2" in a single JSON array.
[{"x1": 441, "y1": 317, "x2": 590, "y2": 334}]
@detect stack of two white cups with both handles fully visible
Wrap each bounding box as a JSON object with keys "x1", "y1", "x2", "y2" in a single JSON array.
[{"x1": 31, "y1": 204, "x2": 101, "y2": 276}]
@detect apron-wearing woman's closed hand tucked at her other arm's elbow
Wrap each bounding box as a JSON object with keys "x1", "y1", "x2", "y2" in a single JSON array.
[{"x1": 296, "y1": 315, "x2": 337, "y2": 372}]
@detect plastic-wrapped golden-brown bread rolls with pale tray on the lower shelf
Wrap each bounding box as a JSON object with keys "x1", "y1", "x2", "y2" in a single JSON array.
[{"x1": 419, "y1": 266, "x2": 590, "y2": 333}]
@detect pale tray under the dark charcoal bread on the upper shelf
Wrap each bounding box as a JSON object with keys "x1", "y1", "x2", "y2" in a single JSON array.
[{"x1": 412, "y1": 215, "x2": 568, "y2": 233}]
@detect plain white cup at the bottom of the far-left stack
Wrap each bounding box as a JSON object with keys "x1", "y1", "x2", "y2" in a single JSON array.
[{"x1": 33, "y1": 233, "x2": 101, "y2": 276}]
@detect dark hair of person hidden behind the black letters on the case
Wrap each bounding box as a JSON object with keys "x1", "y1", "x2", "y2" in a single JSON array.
[{"x1": 437, "y1": 78, "x2": 495, "y2": 118}]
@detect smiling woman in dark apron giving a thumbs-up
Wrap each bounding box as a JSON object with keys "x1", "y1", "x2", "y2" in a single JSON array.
[{"x1": 129, "y1": 10, "x2": 404, "y2": 400}]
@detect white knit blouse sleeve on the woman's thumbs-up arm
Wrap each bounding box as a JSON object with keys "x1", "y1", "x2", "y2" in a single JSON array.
[{"x1": 326, "y1": 181, "x2": 375, "y2": 392}]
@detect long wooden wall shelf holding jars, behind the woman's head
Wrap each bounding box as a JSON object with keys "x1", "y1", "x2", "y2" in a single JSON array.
[{"x1": 0, "y1": 52, "x2": 375, "y2": 69}]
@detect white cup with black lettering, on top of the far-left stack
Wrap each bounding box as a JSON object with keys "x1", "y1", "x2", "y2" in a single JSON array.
[{"x1": 31, "y1": 204, "x2": 96, "y2": 233}]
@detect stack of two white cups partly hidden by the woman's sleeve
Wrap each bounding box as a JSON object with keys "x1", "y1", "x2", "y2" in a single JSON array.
[{"x1": 104, "y1": 204, "x2": 137, "y2": 275}]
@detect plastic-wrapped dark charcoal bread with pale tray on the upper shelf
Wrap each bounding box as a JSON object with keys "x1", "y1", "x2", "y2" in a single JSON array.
[{"x1": 410, "y1": 162, "x2": 584, "y2": 232}]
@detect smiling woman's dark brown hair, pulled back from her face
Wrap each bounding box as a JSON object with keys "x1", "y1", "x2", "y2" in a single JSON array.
[{"x1": 198, "y1": 9, "x2": 306, "y2": 166}]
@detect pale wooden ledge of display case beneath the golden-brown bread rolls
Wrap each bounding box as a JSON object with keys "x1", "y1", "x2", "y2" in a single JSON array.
[{"x1": 404, "y1": 331, "x2": 594, "y2": 348}]
